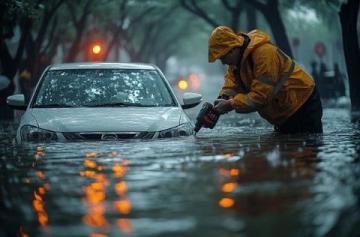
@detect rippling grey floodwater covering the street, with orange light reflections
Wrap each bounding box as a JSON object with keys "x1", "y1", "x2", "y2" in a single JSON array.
[{"x1": 0, "y1": 109, "x2": 360, "y2": 237}]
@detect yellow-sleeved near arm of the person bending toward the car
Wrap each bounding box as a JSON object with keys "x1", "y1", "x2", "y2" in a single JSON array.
[{"x1": 231, "y1": 45, "x2": 281, "y2": 113}]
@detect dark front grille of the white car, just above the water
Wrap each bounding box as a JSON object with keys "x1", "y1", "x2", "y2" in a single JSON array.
[{"x1": 62, "y1": 132, "x2": 155, "y2": 141}]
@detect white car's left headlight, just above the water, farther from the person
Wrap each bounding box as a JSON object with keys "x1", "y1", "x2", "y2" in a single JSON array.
[{"x1": 20, "y1": 125, "x2": 57, "y2": 141}]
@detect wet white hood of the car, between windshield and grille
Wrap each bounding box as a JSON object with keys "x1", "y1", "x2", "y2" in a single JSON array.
[{"x1": 31, "y1": 107, "x2": 186, "y2": 132}]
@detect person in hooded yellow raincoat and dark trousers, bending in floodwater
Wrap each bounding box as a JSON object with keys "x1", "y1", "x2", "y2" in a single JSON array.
[{"x1": 208, "y1": 26, "x2": 322, "y2": 133}]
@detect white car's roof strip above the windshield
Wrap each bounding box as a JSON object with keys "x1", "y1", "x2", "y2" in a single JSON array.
[{"x1": 49, "y1": 63, "x2": 156, "y2": 70}]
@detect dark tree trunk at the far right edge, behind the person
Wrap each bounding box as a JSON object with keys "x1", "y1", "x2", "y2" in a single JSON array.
[{"x1": 339, "y1": 0, "x2": 360, "y2": 111}]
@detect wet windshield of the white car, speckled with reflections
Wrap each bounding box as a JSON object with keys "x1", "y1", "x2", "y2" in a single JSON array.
[{"x1": 33, "y1": 69, "x2": 176, "y2": 108}]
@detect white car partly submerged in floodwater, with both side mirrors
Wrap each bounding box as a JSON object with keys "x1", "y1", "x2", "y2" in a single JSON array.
[{"x1": 7, "y1": 63, "x2": 202, "y2": 143}]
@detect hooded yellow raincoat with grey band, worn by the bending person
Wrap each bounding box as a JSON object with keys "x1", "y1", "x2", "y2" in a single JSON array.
[{"x1": 209, "y1": 26, "x2": 315, "y2": 125}]
